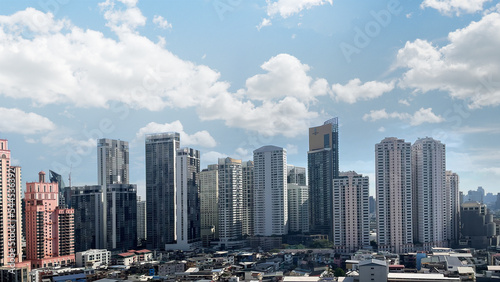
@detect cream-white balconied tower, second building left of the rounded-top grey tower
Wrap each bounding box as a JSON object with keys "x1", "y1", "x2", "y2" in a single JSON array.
[{"x1": 218, "y1": 158, "x2": 243, "y2": 248}]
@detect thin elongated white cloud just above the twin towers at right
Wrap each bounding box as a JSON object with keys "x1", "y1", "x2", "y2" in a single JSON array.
[{"x1": 363, "y1": 108, "x2": 444, "y2": 126}]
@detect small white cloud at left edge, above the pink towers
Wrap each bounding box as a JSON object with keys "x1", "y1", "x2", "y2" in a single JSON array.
[{"x1": 0, "y1": 107, "x2": 56, "y2": 134}]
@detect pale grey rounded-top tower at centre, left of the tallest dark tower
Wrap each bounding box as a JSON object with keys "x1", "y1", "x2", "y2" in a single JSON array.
[{"x1": 253, "y1": 146, "x2": 288, "y2": 236}]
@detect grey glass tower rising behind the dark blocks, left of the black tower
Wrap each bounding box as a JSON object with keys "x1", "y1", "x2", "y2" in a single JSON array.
[{"x1": 97, "y1": 139, "x2": 129, "y2": 248}]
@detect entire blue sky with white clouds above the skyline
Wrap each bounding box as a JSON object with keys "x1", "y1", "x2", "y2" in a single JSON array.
[{"x1": 0, "y1": 0, "x2": 500, "y2": 198}]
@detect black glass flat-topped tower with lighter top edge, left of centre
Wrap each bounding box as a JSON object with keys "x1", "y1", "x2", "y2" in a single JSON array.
[{"x1": 146, "y1": 132, "x2": 180, "y2": 249}]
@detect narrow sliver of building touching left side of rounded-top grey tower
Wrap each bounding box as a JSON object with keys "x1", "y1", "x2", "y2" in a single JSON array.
[{"x1": 241, "y1": 161, "x2": 255, "y2": 236}]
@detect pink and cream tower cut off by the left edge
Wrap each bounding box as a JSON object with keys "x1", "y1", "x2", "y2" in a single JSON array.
[{"x1": 0, "y1": 139, "x2": 23, "y2": 267}]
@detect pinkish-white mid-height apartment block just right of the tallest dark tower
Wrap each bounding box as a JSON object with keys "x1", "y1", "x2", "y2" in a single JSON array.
[{"x1": 333, "y1": 171, "x2": 370, "y2": 253}]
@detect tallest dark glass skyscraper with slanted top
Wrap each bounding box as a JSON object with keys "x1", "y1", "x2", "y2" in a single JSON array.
[{"x1": 307, "y1": 118, "x2": 339, "y2": 240}]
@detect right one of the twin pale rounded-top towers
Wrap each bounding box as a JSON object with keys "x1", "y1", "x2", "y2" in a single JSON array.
[{"x1": 411, "y1": 137, "x2": 451, "y2": 251}]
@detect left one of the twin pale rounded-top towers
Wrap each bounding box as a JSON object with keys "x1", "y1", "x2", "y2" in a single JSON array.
[{"x1": 375, "y1": 137, "x2": 413, "y2": 253}]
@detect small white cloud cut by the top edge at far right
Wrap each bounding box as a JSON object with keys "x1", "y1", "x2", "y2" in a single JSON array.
[{"x1": 420, "y1": 0, "x2": 491, "y2": 16}]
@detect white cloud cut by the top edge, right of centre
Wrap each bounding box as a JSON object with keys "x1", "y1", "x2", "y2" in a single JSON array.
[{"x1": 266, "y1": 0, "x2": 333, "y2": 18}]
